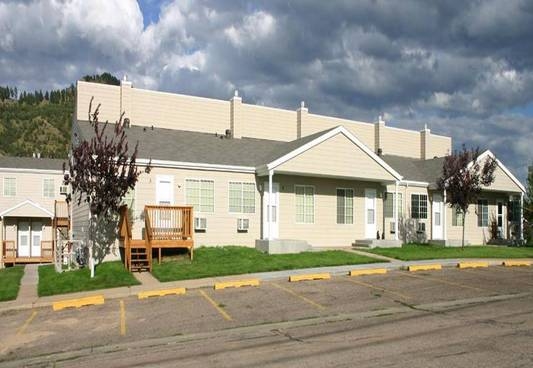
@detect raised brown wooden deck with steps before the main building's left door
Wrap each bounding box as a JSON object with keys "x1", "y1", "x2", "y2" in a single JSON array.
[{"x1": 119, "y1": 205, "x2": 194, "y2": 272}]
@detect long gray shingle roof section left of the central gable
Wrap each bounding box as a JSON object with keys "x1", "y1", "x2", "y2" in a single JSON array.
[{"x1": 77, "y1": 121, "x2": 331, "y2": 167}]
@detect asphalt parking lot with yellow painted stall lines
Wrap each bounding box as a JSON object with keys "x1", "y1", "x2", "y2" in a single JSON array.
[{"x1": 0, "y1": 266, "x2": 533, "y2": 366}]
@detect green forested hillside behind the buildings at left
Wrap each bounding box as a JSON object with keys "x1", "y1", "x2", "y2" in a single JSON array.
[{"x1": 0, "y1": 73, "x2": 120, "y2": 158}]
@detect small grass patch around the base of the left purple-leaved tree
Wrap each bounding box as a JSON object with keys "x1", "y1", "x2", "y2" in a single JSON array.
[{"x1": 37, "y1": 262, "x2": 139, "y2": 296}]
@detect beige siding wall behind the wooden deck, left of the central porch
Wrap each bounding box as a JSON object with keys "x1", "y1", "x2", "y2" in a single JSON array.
[{"x1": 133, "y1": 168, "x2": 261, "y2": 246}]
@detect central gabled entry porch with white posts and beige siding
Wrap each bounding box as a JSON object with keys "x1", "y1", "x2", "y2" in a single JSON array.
[{"x1": 256, "y1": 127, "x2": 401, "y2": 252}]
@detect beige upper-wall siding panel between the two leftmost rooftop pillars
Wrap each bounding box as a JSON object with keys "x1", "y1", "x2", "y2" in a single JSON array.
[{"x1": 130, "y1": 89, "x2": 230, "y2": 133}]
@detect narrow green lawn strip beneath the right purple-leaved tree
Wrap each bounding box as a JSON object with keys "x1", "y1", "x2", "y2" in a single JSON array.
[{"x1": 366, "y1": 244, "x2": 533, "y2": 261}]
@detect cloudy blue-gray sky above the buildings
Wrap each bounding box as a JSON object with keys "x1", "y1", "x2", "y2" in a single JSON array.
[{"x1": 0, "y1": 0, "x2": 533, "y2": 182}]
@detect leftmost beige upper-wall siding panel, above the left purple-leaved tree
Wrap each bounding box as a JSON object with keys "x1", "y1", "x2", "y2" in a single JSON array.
[{"x1": 76, "y1": 81, "x2": 120, "y2": 122}]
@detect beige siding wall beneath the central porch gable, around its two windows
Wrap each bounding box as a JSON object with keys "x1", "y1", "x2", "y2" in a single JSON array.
[{"x1": 273, "y1": 175, "x2": 383, "y2": 247}]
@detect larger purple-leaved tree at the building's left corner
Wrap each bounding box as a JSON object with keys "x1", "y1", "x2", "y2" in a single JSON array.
[{"x1": 64, "y1": 99, "x2": 151, "y2": 277}]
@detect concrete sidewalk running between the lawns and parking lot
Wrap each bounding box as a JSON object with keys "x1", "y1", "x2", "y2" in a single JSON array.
[{"x1": 0, "y1": 249, "x2": 533, "y2": 313}]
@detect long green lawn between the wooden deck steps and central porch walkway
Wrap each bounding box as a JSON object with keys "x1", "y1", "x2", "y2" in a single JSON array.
[{"x1": 152, "y1": 246, "x2": 382, "y2": 282}]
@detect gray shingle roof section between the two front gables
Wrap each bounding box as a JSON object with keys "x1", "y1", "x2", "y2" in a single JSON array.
[{"x1": 381, "y1": 155, "x2": 444, "y2": 185}]
